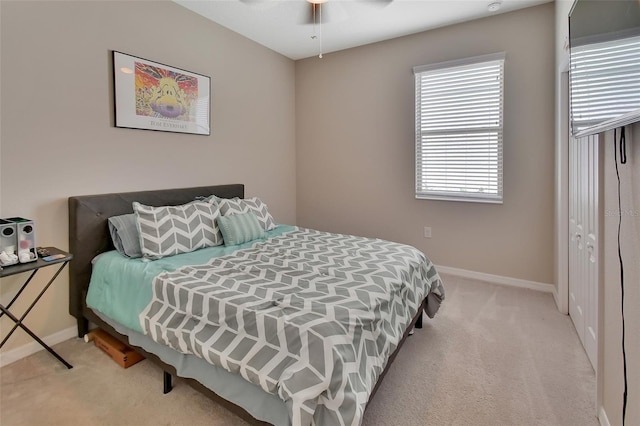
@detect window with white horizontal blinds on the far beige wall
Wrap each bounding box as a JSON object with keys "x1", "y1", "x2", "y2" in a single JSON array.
[{"x1": 413, "y1": 53, "x2": 505, "y2": 203}]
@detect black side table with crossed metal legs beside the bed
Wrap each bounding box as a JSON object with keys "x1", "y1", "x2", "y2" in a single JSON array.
[{"x1": 0, "y1": 247, "x2": 73, "y2": 368}]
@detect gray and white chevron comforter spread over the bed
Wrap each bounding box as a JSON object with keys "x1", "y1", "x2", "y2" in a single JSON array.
[{"x1": 140, "y1": 228, "x2": 444, "y2": 425}]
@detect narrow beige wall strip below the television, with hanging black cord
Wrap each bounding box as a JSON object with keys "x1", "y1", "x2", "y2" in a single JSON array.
[{"x1": 598, "y1": 123, "x2": 640, "y2": 425}]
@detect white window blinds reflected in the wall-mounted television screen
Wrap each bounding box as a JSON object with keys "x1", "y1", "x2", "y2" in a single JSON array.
[{"x1": 570, "y1": 36, "x2": 640, "y2": 134}]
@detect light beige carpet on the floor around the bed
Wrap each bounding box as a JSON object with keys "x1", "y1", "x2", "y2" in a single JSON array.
[{"x1": 0, "y1": 275, "x2": 598, "y2": 426}]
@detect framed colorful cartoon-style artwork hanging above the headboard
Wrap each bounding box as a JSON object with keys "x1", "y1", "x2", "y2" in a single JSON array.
[{"x1": 113, "y1": 51, "x2": 211, "y2": 135}]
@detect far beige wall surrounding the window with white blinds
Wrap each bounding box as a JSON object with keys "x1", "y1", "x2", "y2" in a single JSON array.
[{"x1": 296, "y1": 3, "x2": 554, "y2": 283}]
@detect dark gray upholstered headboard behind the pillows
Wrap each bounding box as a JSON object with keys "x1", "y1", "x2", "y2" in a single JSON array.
[{"x1": 69, "y1": 184, "x2": 244, "y2": 326}]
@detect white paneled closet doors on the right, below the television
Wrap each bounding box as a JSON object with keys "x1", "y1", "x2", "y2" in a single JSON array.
[{"x1": 569, "y1": 135, "x2": 600, "y2": 368}]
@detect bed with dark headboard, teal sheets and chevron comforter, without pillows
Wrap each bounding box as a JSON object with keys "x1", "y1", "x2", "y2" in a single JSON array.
[{"x1": 69, "y1": 184, "x2": 444, "y2": 425}]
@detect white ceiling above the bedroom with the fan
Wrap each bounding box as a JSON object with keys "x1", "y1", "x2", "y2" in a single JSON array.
[{"x1": 173, "y1": 0, "x2": 553, "y2": 60}]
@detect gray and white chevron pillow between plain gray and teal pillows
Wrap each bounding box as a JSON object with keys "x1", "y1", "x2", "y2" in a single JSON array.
[{"x1": 133, "y1": 202, "x2": 223, "y2": 260}]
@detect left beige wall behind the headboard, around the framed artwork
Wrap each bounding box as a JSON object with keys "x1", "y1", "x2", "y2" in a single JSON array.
[{"x1": 0, "y1": 1, "x2": 296, "y2": 351}]
